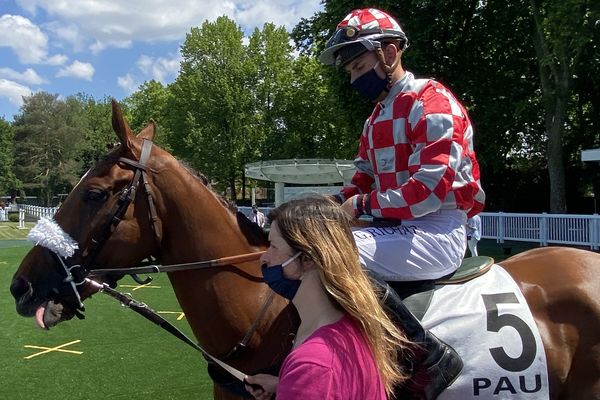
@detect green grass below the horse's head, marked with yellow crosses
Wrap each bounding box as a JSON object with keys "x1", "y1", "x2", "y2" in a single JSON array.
[{"x1": 0, "y1": 242, "x2": 212, "y2": 400}]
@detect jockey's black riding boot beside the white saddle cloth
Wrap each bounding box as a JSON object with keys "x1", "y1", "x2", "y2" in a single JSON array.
[{"x1": 370, "y1": 274, "x2": 463, "y2": 400}]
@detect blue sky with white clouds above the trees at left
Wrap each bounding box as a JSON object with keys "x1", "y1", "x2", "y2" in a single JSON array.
[{"x1": 0, "y1": 0, "x2": 322, "y2": 121}]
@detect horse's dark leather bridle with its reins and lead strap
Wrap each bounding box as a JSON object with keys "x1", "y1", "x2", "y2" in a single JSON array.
[{"x1": 39, "y1": 139, "x2": 275, "y2": 388}]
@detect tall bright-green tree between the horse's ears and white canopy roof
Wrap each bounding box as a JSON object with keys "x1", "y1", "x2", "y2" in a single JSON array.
[{"x1": 167, "y1": 17, "x2": 264, "y2": 198}]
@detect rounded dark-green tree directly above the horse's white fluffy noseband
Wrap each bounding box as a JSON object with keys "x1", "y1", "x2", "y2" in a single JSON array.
[{"x1": 14, "y1": 92, "x2": 83, "y2": 205}]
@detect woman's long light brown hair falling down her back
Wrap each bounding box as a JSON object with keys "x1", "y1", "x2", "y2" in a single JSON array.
[{"x1": 269, "y1": 196, "x2": 411, "y2": 395}]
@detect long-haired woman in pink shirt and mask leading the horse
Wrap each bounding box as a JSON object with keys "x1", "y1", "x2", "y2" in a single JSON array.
[{"x1": 246, "y1": 197, "x2": 410, "y2": 400}]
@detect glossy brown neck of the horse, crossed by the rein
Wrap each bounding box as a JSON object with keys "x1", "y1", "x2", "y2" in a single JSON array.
[{"x1": 152, "y1": 162, "x2": 266, "y2": 354}]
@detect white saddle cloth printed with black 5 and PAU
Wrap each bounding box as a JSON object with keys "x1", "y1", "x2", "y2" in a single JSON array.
[{"x1": 422, "y1": 264, "x2": 548, "y2": 400}]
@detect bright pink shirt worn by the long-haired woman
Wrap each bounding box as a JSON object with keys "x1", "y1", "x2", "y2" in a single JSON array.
[{"x1": 276, "y1": 315, "x2": 387, "y2": 400}]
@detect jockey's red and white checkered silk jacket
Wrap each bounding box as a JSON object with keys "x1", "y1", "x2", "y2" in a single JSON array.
[{"x1": 341, "y1": 72, "x2": 485, "y2": 219}]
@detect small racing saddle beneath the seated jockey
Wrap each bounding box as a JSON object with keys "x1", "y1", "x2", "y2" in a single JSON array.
[{"x1": 388, "y1": 256, "x2": 494, "y2": 321}]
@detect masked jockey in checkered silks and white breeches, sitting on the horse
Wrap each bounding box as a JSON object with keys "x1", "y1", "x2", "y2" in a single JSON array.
[{"x1": 320, "y1": 8, "x2": 485, "y2": 399}]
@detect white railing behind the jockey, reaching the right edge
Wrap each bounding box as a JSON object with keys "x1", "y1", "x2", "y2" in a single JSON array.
[{"x1": 480, "y1": 212, "x2": 600, "y2": 250}]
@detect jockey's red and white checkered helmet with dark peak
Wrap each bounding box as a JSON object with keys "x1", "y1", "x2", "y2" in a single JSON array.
[{"x1": 319, "y1": 8, "x2": 408, "y2": 67}]
